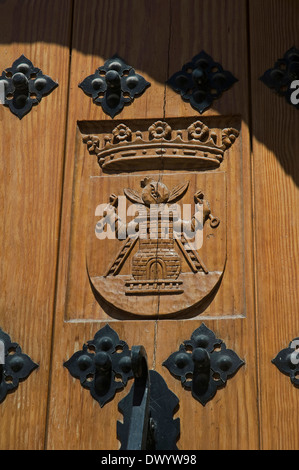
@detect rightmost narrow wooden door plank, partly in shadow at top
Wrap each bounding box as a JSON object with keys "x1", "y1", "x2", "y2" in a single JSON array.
[{"x1": 249, "y1": 0, "x2": 299, "y2": 450}]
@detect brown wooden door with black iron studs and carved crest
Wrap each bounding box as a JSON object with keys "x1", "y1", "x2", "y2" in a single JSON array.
[{"x1": 0, "y1": 0, "x2": 299, "y2": 450}]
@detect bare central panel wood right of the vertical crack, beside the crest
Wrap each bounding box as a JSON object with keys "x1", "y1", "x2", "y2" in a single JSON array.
[{"x1": 156, "y1": 0, "x2": 259, "y2": 450}]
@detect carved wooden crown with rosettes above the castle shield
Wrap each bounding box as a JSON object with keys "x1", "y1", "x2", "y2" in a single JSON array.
[{"x1": 83, "y1": 121, "x2": 239, "y2": 172}]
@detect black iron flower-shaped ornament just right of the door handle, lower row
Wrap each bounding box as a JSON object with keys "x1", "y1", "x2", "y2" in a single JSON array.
[{"x1": 163, "y1": 323, "x2": 244, "y2": 405}]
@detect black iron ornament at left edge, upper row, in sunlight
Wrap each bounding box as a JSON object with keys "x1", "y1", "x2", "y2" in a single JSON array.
[{"x1": 0, "y1": 55, "x2": 58, "y2": 119}]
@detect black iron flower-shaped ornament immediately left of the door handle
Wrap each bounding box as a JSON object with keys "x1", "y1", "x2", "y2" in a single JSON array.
[{"x1": 64, "y1": 325, "x2": 133, "y2": 407}]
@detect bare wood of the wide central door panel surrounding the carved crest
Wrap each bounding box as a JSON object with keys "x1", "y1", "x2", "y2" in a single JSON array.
[{"x1": 47, "y1": 0, "x2": 259, "y2": 449}]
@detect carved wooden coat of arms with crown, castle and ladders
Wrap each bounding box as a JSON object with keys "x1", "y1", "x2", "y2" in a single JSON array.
[{"x1": 83, "y1": 121, "x2": 238, "y2": 318}]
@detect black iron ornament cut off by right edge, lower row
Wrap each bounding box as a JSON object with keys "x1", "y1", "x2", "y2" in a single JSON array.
[{"x1": 272, "y1": 338, "x2": 299, "y2": 387}]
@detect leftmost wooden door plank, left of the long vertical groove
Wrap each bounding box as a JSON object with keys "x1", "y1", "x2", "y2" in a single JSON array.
[{"x1": 0, "y1": 0, "x2": 71, "y2": 450}]
